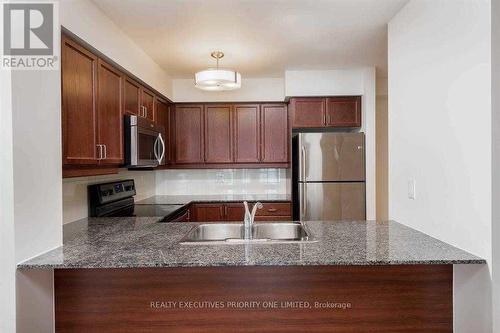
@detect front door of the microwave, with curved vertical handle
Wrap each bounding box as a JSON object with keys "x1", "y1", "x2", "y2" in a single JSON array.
[{"x1": 129, "y1": 126, "x2": 166, "y2": 168}]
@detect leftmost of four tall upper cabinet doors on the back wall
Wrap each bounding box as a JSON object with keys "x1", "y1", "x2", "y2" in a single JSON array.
[{"x1": 174, "y1": 105, "x2": 204, "y2": 164}]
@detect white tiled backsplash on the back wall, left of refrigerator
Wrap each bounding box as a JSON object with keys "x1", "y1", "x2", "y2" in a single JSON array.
[{"x1": 156, "y1": 169, "x2": 290, "y2": 195}]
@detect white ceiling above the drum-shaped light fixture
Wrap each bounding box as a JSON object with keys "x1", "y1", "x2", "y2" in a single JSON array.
[{"x1": 94, "y1": 0, "x2": 408, "y2": 78}]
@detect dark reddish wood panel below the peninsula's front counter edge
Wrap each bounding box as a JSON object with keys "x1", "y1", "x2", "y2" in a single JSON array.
[{"x1": 54, "y1": 265, "x2": 453, "y2": 333}]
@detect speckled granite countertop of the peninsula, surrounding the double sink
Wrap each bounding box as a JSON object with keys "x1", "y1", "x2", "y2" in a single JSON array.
[{"x1": 18, "y1": 217, "x2": 486, "y2": 269}]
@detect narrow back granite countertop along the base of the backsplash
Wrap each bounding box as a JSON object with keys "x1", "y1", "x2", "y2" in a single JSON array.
[{"x1": 135, "y1": 194, "x2": 292, "y2": 205}]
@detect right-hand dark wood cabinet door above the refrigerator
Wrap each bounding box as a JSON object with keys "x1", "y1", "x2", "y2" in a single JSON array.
[{"x1": 326, "y1": 96, "x2": 361, "y2": 127}]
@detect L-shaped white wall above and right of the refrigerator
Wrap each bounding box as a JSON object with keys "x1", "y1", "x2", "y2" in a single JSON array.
[{"x1": 285, "y1": 67, "x2": 376, "y2": 220}]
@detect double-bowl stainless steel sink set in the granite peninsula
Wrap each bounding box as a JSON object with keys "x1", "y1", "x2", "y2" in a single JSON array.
[{"x1": 181, "y1": 223, "x2": 314, "y2": 244}]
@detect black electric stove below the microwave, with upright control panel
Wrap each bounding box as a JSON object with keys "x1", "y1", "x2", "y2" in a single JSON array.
[{"x1": 88, "y1": 179, "x2": 184, "y2": 220}]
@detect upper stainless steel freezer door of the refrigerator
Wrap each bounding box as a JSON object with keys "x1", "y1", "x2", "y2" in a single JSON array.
[{"x1": 296, "y1": 133, "x2": 365, "y2": 181}]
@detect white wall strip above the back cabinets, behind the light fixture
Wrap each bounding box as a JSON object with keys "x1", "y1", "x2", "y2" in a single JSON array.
[{"x1": 172, "y1": 78, "x2": 285, "y2": 102}]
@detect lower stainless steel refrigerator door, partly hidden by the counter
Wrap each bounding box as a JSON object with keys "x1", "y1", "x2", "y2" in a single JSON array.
[{"x1": 299, "y1": 182, "x2": 366, "y2": 221}]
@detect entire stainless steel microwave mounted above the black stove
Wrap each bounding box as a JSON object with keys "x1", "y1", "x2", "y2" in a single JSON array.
[{"x1": 124, "y1": 115, "x2": 167, "y2": 168}]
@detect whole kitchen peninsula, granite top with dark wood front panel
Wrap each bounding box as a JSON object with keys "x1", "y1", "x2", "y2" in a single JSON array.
[{"x1": 18, "y1": 217, "x2": 485, "y2": 332}]
